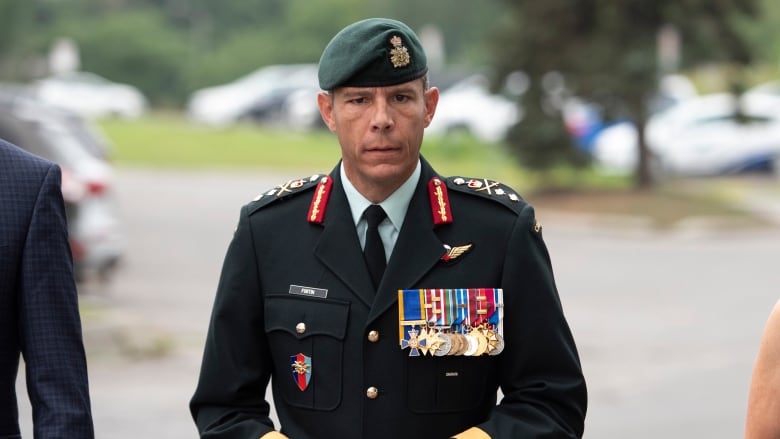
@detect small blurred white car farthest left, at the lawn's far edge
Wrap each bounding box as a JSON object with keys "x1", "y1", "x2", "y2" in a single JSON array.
[{"x1": 33, "y1": 72, "x2": 148, "y2": 118}]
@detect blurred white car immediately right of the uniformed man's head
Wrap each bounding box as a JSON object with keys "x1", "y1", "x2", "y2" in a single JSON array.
[{"x1": 427, "y1": 74, "x2": 522, "y2": 142}]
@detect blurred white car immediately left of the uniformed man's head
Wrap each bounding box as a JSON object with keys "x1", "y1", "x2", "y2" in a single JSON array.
[{"x1": 187, "y1": 64, "x2": 318, "y2": 126}]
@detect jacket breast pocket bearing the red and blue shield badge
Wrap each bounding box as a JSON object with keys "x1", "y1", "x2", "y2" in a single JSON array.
[{"x1": 265, "y1": 296, "x2": 349, "y2": 411}]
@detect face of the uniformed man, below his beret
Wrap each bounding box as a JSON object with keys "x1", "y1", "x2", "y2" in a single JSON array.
[{"x1": 317, "y1": 79, "x2": 439, "y2": 202}]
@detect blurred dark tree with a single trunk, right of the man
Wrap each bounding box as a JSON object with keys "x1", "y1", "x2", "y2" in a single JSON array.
[{"x1": 493, "y1": 0, "x2": 758, "y2": 188}]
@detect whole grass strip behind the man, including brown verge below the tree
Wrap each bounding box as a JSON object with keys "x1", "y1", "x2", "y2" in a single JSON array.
[{"x1": 100, "y1": 114, "x2": 768, "y2": 229}]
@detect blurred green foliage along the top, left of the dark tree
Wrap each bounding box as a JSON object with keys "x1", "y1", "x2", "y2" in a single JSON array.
[{"x1": 0, "y1": 0, "x2": 502, "y2": 106}]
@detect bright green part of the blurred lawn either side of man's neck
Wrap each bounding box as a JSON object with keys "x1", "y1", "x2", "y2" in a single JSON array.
[{"x1": 100, "y1": 114, "x2": 568, "y2": 189}]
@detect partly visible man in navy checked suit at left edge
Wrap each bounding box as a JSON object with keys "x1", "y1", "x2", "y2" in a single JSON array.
[{"x1": 0, "y1": 140, "x2": 94, "y2": 438}]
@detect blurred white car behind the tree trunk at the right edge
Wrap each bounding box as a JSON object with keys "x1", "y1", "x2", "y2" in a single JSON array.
[{"x1": 592, "y1": 93, "x2": 780, "y2": 176}]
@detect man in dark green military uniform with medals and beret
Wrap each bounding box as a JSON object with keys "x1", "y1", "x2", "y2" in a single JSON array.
[{"x1": 190, "y1": 19, "x2": 586, "y2": 439}]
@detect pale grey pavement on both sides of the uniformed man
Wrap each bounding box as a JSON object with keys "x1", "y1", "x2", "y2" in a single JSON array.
[{"x1": 19, "y1": 169, "x2": 780, "y2": 439}]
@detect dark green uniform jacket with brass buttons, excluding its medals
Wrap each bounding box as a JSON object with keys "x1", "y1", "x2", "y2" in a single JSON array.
[{"x1": 190, "y1": 160, "x2": 586, "y2": 439}]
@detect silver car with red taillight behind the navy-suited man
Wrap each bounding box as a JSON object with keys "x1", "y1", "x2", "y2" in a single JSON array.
[{"x1": 0, "y1": 91, "x2": 125, "y2": 280}]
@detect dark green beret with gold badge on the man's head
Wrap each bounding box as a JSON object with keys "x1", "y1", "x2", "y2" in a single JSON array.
[{"x1": 318, "y1": 18, "x2": 428, "y2": 90}]
